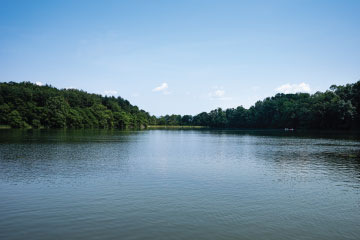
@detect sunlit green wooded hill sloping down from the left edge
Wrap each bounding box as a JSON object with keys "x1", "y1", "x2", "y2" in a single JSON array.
[{"x1": 0, "y1": 82, "x2": 156, "y2": 128}]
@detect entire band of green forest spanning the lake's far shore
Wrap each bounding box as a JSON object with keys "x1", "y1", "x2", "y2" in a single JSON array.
[{"x1": 0, "y1": 81, "x2": 360, "y2": 129}]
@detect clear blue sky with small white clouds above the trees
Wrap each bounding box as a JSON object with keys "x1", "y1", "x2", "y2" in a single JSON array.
[{"x1": 0, "y1": 0, "x2": 360, "y2": 115}]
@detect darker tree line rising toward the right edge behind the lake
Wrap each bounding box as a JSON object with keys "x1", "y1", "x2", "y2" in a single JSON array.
[{"x1": 157, "y1": 81, "x2": 360, "y2": 129}]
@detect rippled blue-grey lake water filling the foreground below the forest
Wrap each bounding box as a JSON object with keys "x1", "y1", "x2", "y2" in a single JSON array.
[{"x1": 0, "y1": 130, "x2": 360, "y2": 240}]
